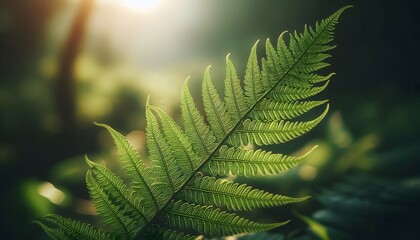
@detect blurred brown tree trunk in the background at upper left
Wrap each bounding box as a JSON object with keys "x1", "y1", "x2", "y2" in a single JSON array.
[{"x1": 55, "y1": 0, "x2": 94, "y2": 143}]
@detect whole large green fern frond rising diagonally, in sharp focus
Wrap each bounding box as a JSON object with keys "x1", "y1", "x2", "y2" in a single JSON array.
[{"x1": 38, "y1": 7, "x2": 348, "y2": 239}]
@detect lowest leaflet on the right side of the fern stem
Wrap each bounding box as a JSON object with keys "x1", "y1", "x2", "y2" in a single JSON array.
[{"x1": 163, "y1": 201, "x2": 288, "y2": 237}]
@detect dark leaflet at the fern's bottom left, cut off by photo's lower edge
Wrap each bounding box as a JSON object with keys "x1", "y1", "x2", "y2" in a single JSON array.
[{"x1": 34, "y1": 214, "x2": 116, "y2": 240}]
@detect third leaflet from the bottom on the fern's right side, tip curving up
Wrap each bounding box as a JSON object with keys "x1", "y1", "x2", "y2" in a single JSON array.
[{"x1": 203, "y1": 146, "x2": 316, "y2": 176}]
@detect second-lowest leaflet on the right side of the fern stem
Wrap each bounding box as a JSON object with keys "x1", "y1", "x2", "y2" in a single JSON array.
[{"x1": 180, "y1": 173, "x2": 308, "y2": 211}]
